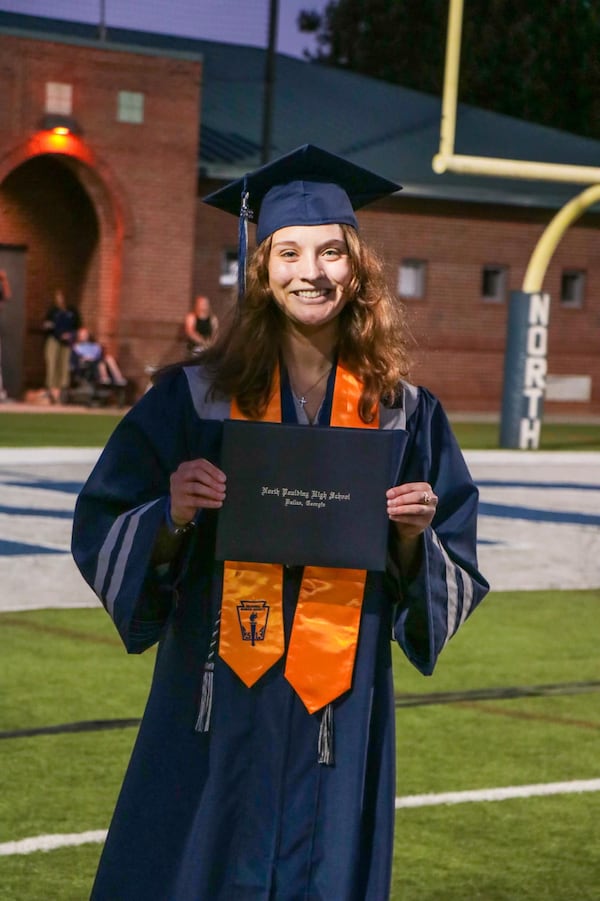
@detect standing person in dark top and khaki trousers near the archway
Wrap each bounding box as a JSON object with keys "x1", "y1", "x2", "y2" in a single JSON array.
[{"x1": 42, "y1": 288, "x2": 81, "y2": 404}]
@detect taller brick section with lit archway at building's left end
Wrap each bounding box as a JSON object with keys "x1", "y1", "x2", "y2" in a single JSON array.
[{"x1": 0, "y1": 15, "x2": 201, "y2": 394}]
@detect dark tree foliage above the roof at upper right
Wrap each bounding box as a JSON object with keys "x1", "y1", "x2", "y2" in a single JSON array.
[{"x1": 298, "y1": 0, "x2": 600, "y2": 139}]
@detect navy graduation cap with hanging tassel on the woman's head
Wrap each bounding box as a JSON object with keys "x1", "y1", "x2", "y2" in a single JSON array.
[{"x1": 204, "y1": 144, "x2": 401, "y2": 299}]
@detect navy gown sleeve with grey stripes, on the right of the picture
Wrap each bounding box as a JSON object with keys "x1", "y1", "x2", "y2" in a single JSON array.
[{"x1": 394, "y1": 388, "x2": 489, "y2": 675}]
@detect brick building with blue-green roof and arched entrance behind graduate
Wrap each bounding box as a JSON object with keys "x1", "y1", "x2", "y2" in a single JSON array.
[{"x1": 0, "y1": 13, "x2": 600, "y2": 413}]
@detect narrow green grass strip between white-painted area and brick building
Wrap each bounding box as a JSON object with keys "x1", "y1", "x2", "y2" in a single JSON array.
[{"x1": 0, "y1": 412, "x2": 600, "y2": 450}]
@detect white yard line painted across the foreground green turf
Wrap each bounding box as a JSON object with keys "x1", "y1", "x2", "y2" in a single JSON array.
[{"x1": 0, "y1": 779, "x2": 600, "y2": 857}]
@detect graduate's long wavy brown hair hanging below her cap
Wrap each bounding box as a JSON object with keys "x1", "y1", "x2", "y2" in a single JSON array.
[{"x1": 199, "y1": 225, "x2": 409, "y2": 422}]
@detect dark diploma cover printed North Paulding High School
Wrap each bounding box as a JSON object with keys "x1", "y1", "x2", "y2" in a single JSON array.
[{"x1": 215, "y1": 420, "x2": 407, "y2": 570}]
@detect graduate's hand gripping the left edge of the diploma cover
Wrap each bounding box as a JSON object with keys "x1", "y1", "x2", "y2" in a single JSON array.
[{"x1": 171, "y1": 458, "x2": 226, "y2": 526}]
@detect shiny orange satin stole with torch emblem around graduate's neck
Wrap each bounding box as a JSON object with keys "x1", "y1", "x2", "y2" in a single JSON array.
[{"x1": 219, "y1": 363, "x2": 379, "y2": 713}]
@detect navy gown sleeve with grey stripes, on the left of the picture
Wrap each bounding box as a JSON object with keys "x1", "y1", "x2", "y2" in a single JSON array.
[{"x1": 71, "y1": 370, "x2": 204, "y2": 653}]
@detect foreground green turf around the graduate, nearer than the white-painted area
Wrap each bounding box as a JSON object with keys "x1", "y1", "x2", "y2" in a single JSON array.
[{"x1": 0, "y1": 590, "x2": 600, "y2": 901}]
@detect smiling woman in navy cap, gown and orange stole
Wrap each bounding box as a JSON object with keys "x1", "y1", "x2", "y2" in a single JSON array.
[{"x1": 73, "y1": 145, "x2": 488, "y2": 901}]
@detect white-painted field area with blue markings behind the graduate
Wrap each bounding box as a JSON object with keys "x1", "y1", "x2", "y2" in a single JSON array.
[{"x1": 0, "y1": 448, "x2": 600, "y2": 611}]
